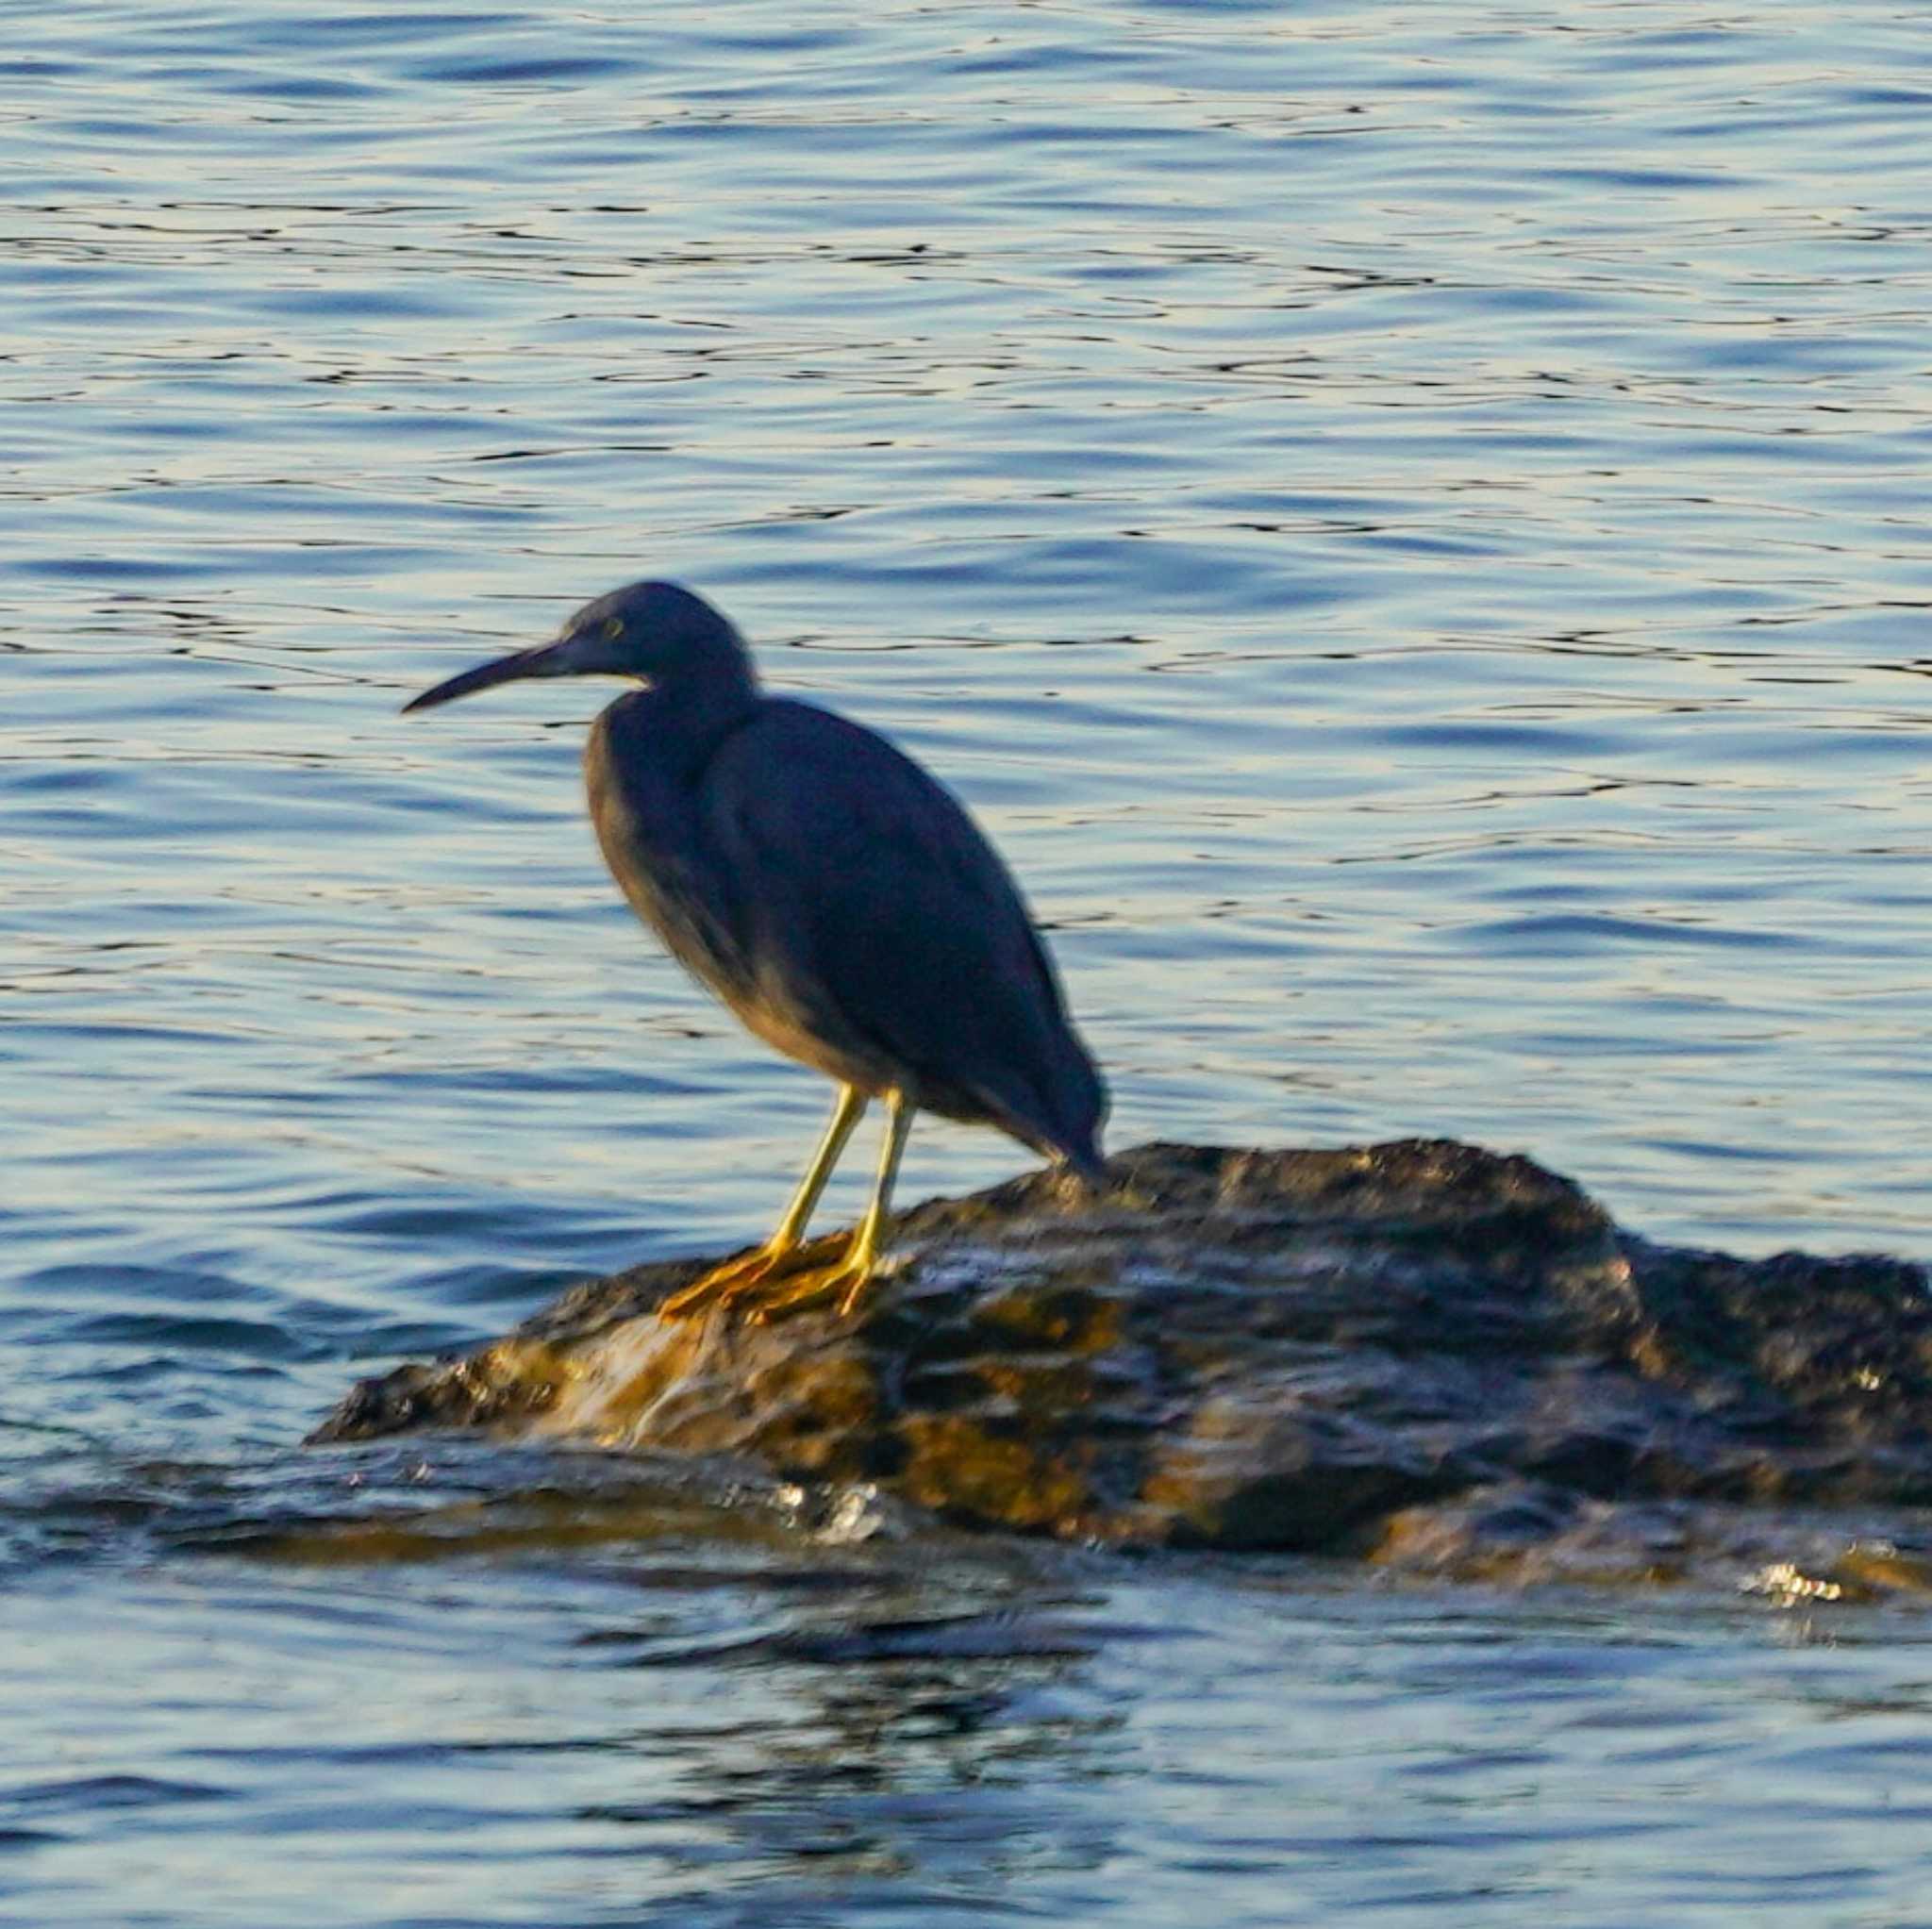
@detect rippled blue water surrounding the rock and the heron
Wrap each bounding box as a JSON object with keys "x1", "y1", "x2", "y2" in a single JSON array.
[{"x1": 0, "y1": 0, "x2": 1932, "y2": 1929}]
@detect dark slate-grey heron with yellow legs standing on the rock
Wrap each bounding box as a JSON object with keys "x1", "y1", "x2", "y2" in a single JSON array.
[{"x1": 404, "y1": 583, "x2": 1108, "y2": 1319}]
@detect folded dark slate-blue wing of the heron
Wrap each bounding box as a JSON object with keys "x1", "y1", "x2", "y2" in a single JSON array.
[{"x1": 703, "y1": 701, "x2": 1101, "y2": 1155}]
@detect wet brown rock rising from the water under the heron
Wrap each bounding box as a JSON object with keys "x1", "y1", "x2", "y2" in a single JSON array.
[{"x1": 313, "y1": 1141, "x2": 1932, "y2": 1586}]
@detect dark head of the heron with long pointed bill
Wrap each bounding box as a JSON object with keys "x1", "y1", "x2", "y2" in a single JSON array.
[{"x1": 404, "y1": 583, "x2": 752, "y2": 712}]
